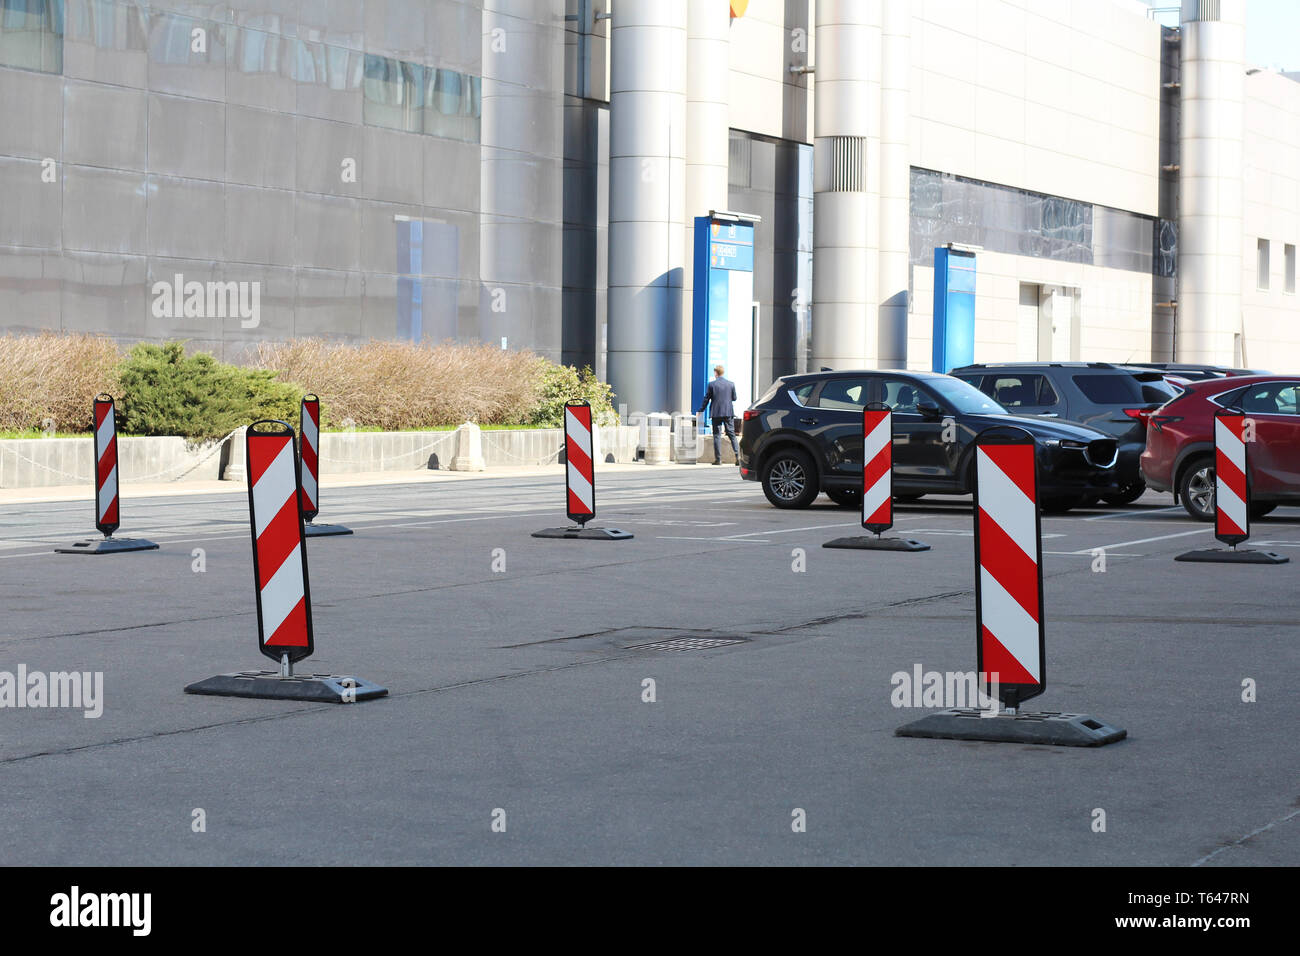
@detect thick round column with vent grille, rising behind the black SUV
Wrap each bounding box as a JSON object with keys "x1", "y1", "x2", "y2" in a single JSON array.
[{"x1": 811, "y1": 0, "x2": 880, "y2": 369}]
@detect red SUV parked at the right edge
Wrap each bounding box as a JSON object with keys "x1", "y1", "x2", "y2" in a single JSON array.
[{"x1": 1141, "y1": 375, "x2": 1300, "y2": 522}]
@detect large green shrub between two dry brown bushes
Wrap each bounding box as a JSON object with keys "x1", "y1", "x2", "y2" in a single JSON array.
[{"x1": 117, "y1": 342, "x2": 303, "y2": 441}]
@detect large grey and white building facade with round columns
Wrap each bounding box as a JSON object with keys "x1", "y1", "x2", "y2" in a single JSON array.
[{"x1": 0, "y1": 0, "x2": 1300, "y2": 411}]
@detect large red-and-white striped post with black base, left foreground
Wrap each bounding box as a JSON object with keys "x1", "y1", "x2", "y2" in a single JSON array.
[{"x1": 185, "y1": 421, "x2": 387, "y2": 704}]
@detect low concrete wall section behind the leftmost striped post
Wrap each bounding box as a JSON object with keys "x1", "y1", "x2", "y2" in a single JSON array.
[{"x1": 0, "y1": 437, "x2": 228, "y2": 488}]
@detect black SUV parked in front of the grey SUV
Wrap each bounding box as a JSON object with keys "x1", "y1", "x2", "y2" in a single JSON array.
[{"x1": 740, "y1": 369, "x2": 1115, "y2": 511}]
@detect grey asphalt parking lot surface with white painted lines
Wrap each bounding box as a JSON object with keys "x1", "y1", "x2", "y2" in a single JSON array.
[{"x1": 0, "y1": 466, "x2": 1300, "y2": 865}]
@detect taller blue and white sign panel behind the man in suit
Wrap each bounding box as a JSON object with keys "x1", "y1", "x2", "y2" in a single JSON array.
[{"x1": 690, "y1": 216, "x2": 754, "y2": 428}]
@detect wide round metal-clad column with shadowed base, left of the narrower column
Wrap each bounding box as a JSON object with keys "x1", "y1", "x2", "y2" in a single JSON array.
[{"x1": 608, "y1": 0, "x2": 686, "y2": 411}]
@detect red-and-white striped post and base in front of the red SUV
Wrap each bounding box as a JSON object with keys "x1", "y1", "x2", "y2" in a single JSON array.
[{"x1": 1174, "y1": 408, "x2": 1290, "y2": 564}]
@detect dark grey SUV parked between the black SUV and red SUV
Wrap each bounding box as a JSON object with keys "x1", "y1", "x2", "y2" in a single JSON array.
[{"x1": 953, "y1": 362, "x2": 1178, "y2": 505}]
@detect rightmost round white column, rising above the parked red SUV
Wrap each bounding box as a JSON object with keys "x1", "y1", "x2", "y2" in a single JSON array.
[{"x1": 1174, "y1": 0, "x2": 1245, "y2": 364}]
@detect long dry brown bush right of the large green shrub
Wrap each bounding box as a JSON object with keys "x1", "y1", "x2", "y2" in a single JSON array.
[{"x1": 252, "y1": 338, "x2": 543, "y2": 431}]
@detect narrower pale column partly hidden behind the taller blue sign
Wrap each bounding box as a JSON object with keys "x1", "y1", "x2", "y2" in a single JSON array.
[{"x1": 668, "y1": 0, "x2": 731, "y2": 410}]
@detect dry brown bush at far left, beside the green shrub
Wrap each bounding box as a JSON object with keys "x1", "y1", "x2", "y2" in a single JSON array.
[{"x1": 0, "y1": 332, "x2": 121, "y2": 432}]
